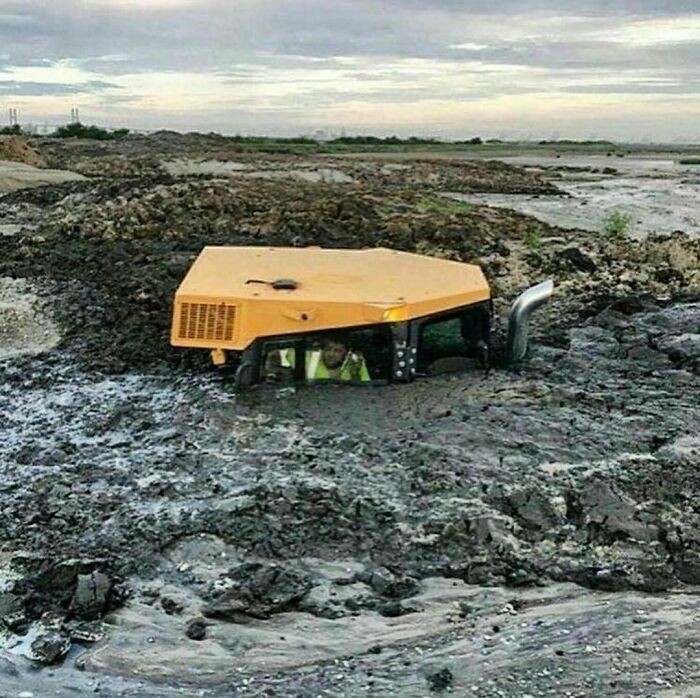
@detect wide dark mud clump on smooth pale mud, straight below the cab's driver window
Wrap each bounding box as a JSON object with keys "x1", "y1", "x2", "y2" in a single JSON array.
[{"x1": 203, "y1": 562, "x2": 311, "y2": 623}]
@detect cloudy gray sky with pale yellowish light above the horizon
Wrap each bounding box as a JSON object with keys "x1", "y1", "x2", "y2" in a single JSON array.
[{"x1": 0, "y1": 0, "x2": 700, "y2": 141}]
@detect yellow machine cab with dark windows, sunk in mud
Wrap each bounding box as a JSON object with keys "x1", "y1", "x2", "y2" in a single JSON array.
[{"x1": 171, "y1": 247, "x2": 492, "y2": 387}]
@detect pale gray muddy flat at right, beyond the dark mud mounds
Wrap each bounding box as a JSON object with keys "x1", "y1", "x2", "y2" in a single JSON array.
[{"x1": 448, "y1": 156, "x2": 700, "y2": 239}]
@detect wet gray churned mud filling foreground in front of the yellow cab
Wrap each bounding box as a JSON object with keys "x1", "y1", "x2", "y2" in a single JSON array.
[{"x1": 0, "y1": 303, "x2": 700, "y2": 696}]
